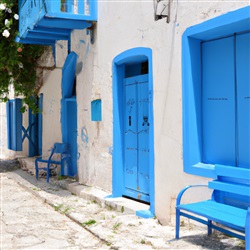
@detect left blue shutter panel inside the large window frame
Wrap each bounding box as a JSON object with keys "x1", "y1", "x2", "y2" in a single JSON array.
[{"x1": 202, "y1": 37, "x2": 236, "y2": 166}]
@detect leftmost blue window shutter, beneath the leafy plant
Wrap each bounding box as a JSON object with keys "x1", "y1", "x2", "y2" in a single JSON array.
[{"x1": 6, "y1": 99, "x2": 23, "y2": 151}]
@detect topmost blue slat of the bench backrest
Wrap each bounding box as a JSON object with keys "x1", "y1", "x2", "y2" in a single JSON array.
[{"x1": 215, "y1": 164, "x2": 250, "y2": 180}]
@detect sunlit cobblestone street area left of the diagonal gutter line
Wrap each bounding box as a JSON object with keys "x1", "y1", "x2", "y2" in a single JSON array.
[{"x1": 0, "y1": 161, "x2": 105, "y2": 250}]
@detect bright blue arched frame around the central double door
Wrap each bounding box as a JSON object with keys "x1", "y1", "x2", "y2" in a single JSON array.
[{"x1": 112, "y1": 47, "x2": 155, "y2": 218}]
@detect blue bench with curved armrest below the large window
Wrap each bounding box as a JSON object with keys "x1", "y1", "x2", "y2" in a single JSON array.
[{"x1": 175, "y1": 165, "x2": 250, "y2": 250}]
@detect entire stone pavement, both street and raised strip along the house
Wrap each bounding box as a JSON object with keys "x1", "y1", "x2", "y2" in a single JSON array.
[{"x1": 0, "y1": 160, "x2": 244, "y2": 250}]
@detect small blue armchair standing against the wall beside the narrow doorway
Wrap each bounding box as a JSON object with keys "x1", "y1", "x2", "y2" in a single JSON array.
[{"x1": 35, "y1": 142, "x2": 70, "y2": 182}]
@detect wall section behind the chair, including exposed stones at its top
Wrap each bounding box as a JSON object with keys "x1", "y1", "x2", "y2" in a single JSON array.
[{"x1": 39, "y1": 44, "x2": 64, "y2": 156}]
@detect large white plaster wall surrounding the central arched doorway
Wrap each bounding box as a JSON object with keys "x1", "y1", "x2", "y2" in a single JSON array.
[{"x1": 71, "y1": 0, "x2": 247, "y2": 223}]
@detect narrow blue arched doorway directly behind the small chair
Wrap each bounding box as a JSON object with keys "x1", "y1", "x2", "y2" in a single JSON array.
[{"x1": 61, "y1": 52, "x2": 78, "y2": 177}]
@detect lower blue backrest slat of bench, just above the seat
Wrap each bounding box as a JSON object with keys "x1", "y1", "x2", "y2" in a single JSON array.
[{"x1": 208, "y1": 181, "x2": 250, "y2": 196}]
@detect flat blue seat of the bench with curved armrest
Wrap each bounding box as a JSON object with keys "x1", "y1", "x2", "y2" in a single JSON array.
[{"x1": 177, "y1": 200, "x2": 247, "y2": 231}]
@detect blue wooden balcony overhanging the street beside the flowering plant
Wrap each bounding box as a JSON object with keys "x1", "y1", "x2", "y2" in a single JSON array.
[{"x1": 17, "y1": 0, "x2": 97, "y2": 45}]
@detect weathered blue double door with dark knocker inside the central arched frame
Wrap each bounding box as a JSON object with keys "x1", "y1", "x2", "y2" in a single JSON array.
[{"x1": 124, "y1": 74, "x2": 150, "y2": 202}]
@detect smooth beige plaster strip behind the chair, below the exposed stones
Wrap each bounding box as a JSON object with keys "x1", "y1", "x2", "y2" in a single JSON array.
[{"x1": 39, "y1": 68, "x2": 62, "y2": 155}]
